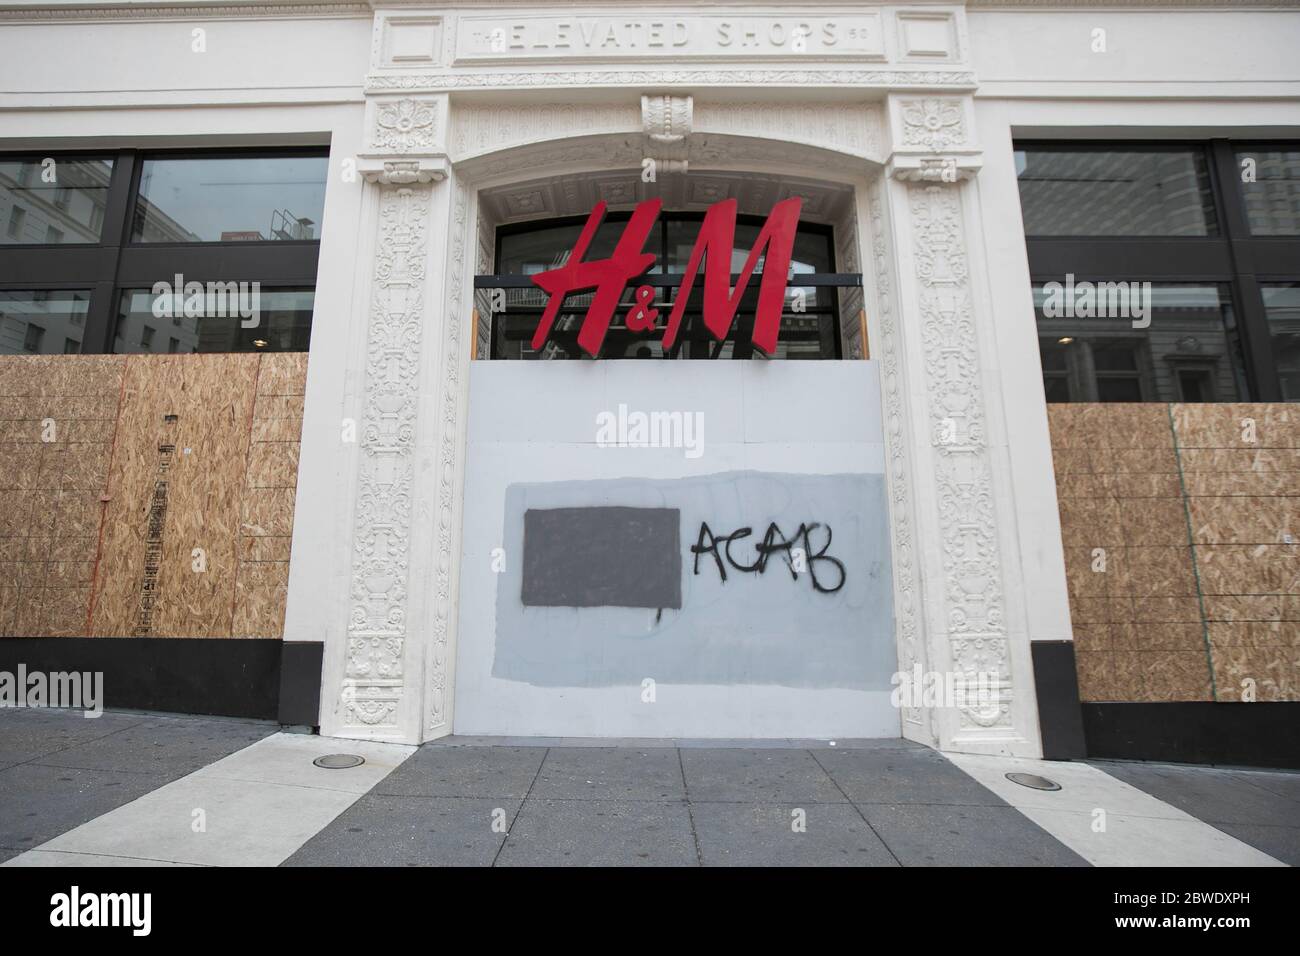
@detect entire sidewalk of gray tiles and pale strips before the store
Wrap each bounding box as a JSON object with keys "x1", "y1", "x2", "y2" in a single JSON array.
[{"x1": 0, "y1": 710, "x2": 1300, "y2": 866}]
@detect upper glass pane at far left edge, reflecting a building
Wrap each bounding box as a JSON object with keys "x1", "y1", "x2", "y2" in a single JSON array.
[{"x1": 0, "y1": 156, "x2": 113, "y2": 245}]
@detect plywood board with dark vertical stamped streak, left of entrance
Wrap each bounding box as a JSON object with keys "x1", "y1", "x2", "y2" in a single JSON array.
[{"x1": 92, "y1": 355, "x2": 261, "y2": 637}]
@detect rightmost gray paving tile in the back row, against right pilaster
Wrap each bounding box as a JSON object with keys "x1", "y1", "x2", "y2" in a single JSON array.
[{"x1": 816, "y1": 748, "x2": 1006, "y2": 806}]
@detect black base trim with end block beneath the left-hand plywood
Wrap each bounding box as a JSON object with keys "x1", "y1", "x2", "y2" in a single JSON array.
[{"x1": 0, "y1": 637, "x2": 324, "y2": 724}]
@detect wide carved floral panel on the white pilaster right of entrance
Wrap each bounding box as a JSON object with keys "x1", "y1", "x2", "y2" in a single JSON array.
[{"x1": 907, "y1": 185, "x2": 1011, "y2": 731}]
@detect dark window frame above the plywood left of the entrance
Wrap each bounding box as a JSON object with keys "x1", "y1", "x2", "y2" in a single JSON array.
[{"x1": 0, "y1": 146, "x2": 329, "y2": 355}]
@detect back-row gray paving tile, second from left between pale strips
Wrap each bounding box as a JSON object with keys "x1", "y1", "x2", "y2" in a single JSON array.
[{"x1": 530, "y1": 748, "x2": 686, "y2": 800}]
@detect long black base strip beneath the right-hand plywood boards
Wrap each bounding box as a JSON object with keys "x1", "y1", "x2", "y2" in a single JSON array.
[{"x1": 1083, "y1": 701, "x2": 1300, "y2": 769}]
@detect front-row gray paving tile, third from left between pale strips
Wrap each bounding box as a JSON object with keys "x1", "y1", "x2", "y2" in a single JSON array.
[{"x1": 690, "y1": 803, "x2": 898, "y2": 866}]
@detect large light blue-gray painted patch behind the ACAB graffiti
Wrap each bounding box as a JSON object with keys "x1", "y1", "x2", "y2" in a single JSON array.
[{"x1": 491, "y1": 471, "x2": 897, "y2": 691}]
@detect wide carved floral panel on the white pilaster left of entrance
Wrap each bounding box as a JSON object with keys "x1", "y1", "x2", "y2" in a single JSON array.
[{"x1": 342, "y1": 186, "x2": 432, "y2": 728}]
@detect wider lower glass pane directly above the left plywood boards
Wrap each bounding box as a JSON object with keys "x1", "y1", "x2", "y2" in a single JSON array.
[{"x1": 113, "y1": 290, "x2": 315, "y2": 354}]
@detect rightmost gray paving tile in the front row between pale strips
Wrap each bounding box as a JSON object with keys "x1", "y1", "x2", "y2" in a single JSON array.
[{"x1": 859, "y1": 804, "x2": 1088, "y2": 866}]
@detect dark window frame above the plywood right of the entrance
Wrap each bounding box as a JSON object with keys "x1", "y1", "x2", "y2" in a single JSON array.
[{"x1": 1013, "y1": 137, "x2": 1300, "y2": 402}]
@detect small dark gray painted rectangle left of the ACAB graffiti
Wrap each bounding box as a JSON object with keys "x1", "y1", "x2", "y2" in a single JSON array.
[{"x1": 523, "y1": 507, "x2": 681, "y2": 607}]
